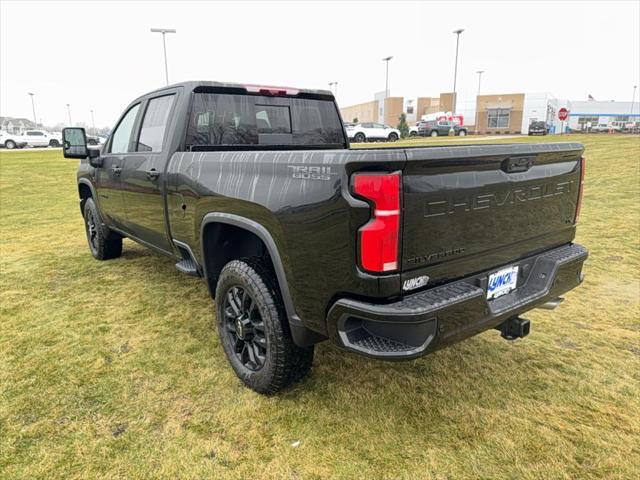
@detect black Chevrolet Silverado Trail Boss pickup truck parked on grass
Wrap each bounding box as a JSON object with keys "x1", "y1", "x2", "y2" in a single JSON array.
[{"x1": 63, "y1": 82, "x2": 587, "y2": 393}]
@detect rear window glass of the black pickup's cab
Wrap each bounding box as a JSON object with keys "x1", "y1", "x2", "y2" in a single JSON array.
[{"x1": 186, "y1": 92, "x2": 346, "y2": 150}]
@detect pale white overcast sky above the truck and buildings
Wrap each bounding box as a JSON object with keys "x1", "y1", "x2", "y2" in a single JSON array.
[{"x1": 0, "y1": 0, "x2": 640, "y2": 127}]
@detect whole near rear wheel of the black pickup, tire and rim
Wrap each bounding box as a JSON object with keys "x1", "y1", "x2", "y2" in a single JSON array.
[{"x1": 216, "y1": 258, "x2": 314, "y2": 394}]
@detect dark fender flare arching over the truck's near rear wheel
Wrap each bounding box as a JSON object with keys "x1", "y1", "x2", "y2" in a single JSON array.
[{"x1": 200, "y1": 212, "x2": 304, "y2": 330}]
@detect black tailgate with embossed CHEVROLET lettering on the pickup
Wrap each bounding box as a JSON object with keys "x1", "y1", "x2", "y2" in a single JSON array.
[{"x1": 402, "y1": 143, "x2": 583, "y2": 285}]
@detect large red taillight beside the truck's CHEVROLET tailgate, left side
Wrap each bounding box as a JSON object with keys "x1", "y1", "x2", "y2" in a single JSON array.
[{"x1": 353, "y1": 172, "x2": 402, "y2": 272}]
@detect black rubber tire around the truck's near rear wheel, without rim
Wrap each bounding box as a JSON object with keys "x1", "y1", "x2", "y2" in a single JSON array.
[{"x1": 216, "y1": 257, "x2": 314, "y2": 395}]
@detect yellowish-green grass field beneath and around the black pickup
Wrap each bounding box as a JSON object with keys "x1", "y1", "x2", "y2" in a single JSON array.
[{"x1": 0, "y1": 135, "x2": 640, "y2": 479}]
